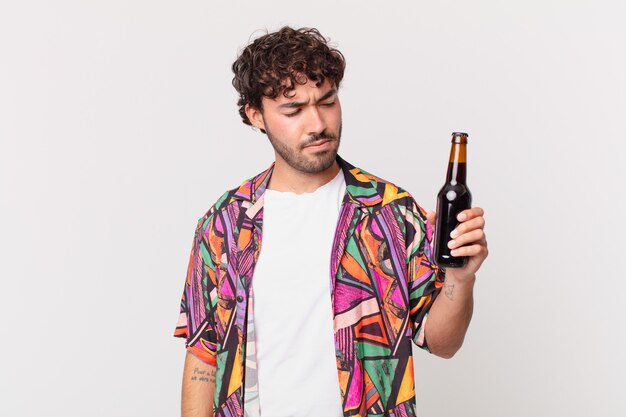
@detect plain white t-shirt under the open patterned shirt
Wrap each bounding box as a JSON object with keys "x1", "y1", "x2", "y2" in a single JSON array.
[{"x1": 252, "y1": 170, "x2": 346, "y2": 417}]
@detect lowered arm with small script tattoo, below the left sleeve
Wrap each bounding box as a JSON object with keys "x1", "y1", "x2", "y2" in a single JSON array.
[{"x1": 181, "y1": 351, "x2": 215, "y2": 417}]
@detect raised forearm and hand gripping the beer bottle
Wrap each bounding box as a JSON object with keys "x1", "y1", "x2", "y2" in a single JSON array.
[{"x1": 424, "y1": 207, "x2": 488, "y2": 358}]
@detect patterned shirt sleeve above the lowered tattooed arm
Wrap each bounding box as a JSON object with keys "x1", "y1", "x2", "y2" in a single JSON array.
[{"x1": 174, "y1": 216, "x2": 217, "y2": 366}]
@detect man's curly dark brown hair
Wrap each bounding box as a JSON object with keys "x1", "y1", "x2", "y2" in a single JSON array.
[{"x1": 232, "y1": 26, "x2": 346, "y2": 129}]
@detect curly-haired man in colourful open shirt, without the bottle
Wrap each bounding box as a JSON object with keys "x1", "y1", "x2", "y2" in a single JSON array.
[{"x1": 175, "y1": 27, "x2": 487, "y2": 417}]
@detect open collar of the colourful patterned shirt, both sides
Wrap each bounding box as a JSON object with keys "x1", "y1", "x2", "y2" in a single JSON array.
[{"x1": 230, "y1": 155, "x2": 388, "y2": 211}]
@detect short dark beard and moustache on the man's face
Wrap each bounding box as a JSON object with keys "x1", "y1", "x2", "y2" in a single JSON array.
[{"x1": 265, "y1": 122, "x2": 342, "y2": 174}]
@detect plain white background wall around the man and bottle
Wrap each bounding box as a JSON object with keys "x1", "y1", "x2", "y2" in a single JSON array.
[{"x1": 0, "y1": 0, "x2": 626, "y2": 417}]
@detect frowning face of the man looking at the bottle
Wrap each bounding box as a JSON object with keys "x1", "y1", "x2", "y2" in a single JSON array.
[{"x1": 248, "y1": 79, "x2": 341, "y2": 173}]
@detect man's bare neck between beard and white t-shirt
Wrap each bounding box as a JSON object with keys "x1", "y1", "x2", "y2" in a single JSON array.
[{"x1": 267, "y1": 157, "x2": 341, "y2": 194}]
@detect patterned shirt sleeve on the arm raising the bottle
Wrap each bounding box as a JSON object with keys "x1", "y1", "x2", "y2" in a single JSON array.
[{"x1": 406, "y1": 197, "x2": 445, "y2": 351}]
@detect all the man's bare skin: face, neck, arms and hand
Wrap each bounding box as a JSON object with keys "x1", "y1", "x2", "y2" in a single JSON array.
[{"x1": 182, "y1": 73, "x2": 488, "y2": 417}]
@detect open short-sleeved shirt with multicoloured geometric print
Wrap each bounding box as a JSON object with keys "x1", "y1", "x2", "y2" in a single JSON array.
[{"x1": 174, "y1": 155, "x2": 445, "y2": 417}]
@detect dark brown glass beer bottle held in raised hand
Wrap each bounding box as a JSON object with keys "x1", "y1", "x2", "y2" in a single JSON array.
[{"x1": 435, "y1": 132, "x2": 472, "y2": 268}]
